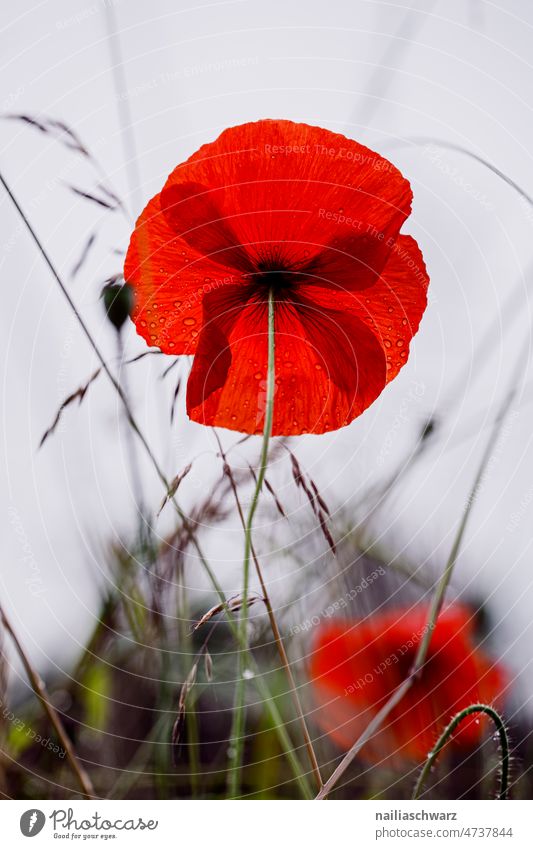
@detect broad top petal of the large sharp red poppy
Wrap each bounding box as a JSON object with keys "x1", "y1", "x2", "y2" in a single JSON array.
[{"x1": 158, "y1": 120, "x2": 412, "y2": 264}]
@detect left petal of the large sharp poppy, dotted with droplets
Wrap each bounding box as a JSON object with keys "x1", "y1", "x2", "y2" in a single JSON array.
[{"x1": 124, "y1": 195, "x2": 244, "y2": 354}]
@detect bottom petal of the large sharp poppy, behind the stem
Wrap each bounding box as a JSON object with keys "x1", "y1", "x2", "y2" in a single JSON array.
[{"x1": 187, "y1": 286, "x2": 386, "y2": 435}]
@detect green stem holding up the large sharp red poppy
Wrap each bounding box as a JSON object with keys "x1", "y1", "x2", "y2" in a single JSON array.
[{"x1": 228, "y1": 290, "x2": 275, "y2": 799}]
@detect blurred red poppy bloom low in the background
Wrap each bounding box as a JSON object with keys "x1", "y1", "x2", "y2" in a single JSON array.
[{"x1": 310, "y1": 605, "x2": 505, "y2": 761}]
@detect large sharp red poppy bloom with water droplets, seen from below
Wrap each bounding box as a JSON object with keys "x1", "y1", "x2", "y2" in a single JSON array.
[{"x1": 124, "y1": 121, "x2": 428, "y2": 435}]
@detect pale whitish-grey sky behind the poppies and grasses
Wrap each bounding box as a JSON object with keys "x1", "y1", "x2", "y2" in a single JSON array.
[{"x1": 0, "y1": 0, "x2": 533, "y2": 701}]
